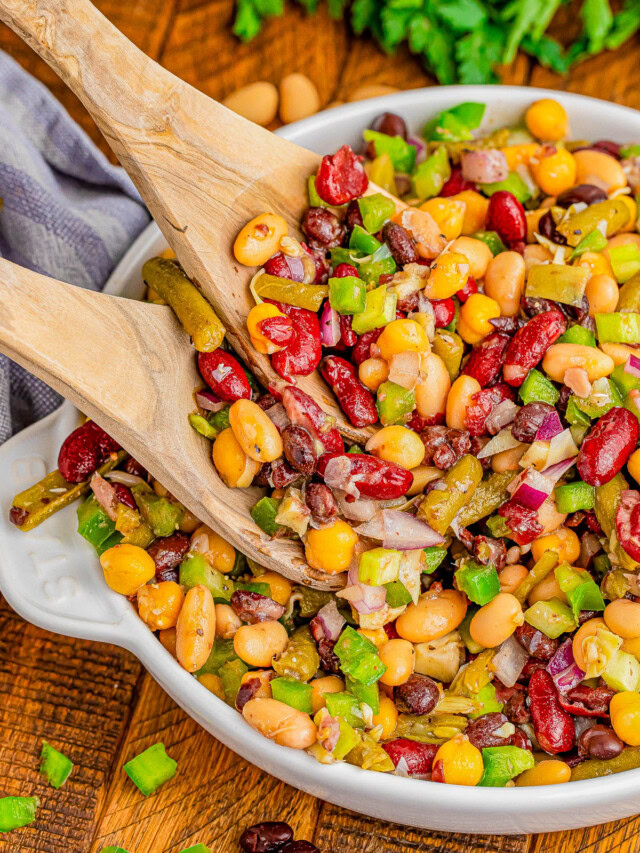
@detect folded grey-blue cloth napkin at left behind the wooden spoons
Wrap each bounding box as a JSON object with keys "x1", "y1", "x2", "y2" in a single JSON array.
[{"x1": 0, "y1": 51, "x2": 149, "y2": 444}]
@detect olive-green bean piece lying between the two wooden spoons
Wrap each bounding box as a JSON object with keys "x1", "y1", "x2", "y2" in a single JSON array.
[{"x1": 142, "y1": 258, "x2": 225, "y2": 352}]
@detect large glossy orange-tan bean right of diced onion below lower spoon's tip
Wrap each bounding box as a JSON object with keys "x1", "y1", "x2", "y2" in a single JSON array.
[{"x1": 396, "y1": 589, "x2": 467, "y2": 643}]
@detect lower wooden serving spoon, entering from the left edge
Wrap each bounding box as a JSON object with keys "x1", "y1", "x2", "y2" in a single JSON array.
[{"x1": 0, "y1": 259, "x2": 344, "y2": 589}]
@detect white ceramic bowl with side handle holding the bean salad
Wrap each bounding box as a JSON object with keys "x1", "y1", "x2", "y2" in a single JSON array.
[{"x1": 0, "y1": 86, "x2": 640, "y2": 833}]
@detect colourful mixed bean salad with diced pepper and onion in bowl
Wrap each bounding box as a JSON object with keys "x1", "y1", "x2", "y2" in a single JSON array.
[{"x1": 11, "y1": 99, "x2": 640, "y2": 788}]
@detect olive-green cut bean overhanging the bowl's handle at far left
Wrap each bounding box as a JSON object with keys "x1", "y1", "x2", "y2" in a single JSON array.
[{"x1": 10, "y1": 450, "x2": 129, "y2": 531}]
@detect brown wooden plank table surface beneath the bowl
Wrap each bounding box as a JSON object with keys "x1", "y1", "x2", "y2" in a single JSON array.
[{"x1": 0, "y1": 0, "x2": 640, "y2": 853}]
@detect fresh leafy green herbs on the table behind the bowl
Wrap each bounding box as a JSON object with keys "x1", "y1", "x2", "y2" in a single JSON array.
[{"x1": 233, "y1": 0, "x2": 640, "y2": 84}]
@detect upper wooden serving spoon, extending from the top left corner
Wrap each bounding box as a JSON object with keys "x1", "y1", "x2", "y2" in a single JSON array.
[{"x1": 0, "y1": 0, "x2": 404, "y2": 443}]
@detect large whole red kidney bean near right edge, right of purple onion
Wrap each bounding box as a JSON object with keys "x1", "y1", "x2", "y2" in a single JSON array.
[{"x1": 578, "y1": 406, "x2": 638, "y2": 486}]
